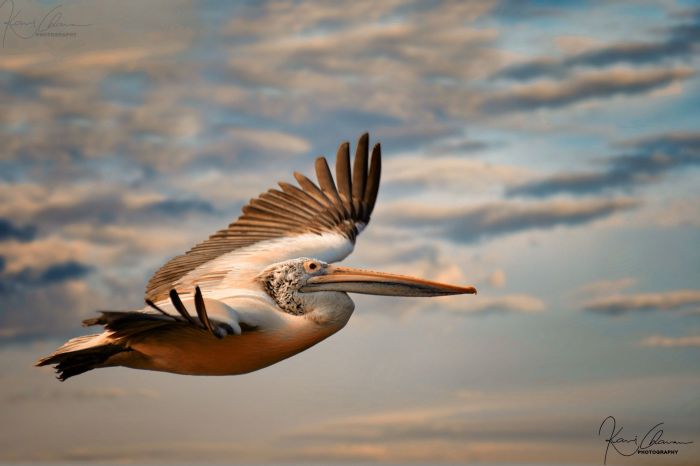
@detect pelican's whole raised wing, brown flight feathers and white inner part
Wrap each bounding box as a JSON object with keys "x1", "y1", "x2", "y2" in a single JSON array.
[{"x1": 146, "y1": 134, "x2": 381, "y2": 302}]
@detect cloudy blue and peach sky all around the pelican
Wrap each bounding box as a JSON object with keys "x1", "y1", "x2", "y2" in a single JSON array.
[{"x1": 0, "y1": 0, "x2": 700, "y2": 465}]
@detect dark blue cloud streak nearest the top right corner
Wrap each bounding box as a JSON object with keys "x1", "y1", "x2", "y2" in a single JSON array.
[{"x1": 494, "y1": 10, "x2": 700, "y2": 81}]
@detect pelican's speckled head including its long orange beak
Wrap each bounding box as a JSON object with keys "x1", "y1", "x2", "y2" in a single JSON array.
[{"x1": 259, "y1": 257, "x2": 476, "y2": 315}]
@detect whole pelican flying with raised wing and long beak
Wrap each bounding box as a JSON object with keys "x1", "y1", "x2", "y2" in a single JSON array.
[{"x1": 36, "y1": 134, "x2": 476, "y2": 381}]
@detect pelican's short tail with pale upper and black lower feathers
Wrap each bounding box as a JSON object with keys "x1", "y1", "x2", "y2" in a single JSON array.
[{"x1": 36, "y1": 335, "x2": 131, "y2": 381}]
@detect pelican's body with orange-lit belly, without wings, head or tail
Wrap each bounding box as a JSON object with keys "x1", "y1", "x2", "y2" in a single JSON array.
[{"x1": 118, "y1": 292, "x2": 355, "y2": 375}]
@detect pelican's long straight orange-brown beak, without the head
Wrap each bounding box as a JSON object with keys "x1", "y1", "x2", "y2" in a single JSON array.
[{"x1": 299, "y1": 265, "x2": 476, "y2": 296}]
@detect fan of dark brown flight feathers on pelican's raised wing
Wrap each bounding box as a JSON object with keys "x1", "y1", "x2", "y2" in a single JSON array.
[{"x1": 146, "y1": 134, "x2": 381, "y2": 302}]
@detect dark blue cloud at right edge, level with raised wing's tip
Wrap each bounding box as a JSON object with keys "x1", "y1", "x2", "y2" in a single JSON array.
[{"x1": 507, "y1": 132, "x2": 700, "y2": 197}]
